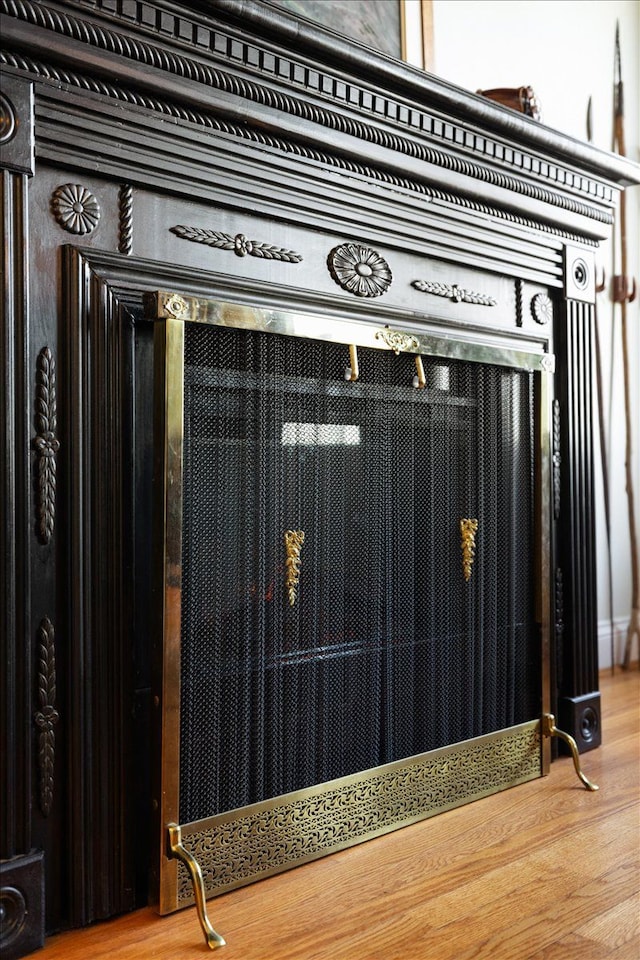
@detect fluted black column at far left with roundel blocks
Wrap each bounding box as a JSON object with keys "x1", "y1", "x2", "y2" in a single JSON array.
[{"x1": 0, "y1": 77, "x2": 44, "y2": 960}]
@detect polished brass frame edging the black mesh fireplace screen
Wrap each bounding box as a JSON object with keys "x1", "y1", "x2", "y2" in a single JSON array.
[{"x1": 145, "y1": 291, "x2": 554, "y2": 914}]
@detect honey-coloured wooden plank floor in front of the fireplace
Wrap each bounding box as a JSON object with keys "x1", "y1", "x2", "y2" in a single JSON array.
[{"x1": 34, "y1": 666, "x2": 640, "y2": 960}]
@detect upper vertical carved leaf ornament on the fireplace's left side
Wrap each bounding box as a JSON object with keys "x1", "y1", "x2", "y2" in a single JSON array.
[{"x1": 33, "y1": 347, "x2": 60, "y2": 544}]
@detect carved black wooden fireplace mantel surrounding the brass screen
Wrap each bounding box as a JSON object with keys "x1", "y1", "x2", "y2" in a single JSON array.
[{"x1": 0, "y1": 0, "x2": 640, "y2": 958}]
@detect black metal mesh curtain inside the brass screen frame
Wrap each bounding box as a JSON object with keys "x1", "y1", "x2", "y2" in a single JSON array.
[{"x1": 180, "y1": 324, "x2": 540, "y2": 823}]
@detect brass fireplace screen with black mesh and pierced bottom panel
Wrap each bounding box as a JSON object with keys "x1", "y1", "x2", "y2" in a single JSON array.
[{"x1": 145, "y1": 292, "x2": 584, "y2": 946}]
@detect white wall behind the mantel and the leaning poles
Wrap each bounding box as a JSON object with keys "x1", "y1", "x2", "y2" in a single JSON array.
[{"x1": 432, "y1": 0, "x2": 640, "y2": 667}]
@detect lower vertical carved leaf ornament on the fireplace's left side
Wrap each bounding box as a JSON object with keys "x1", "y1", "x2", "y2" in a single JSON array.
[{"x1": 34, "y1": 617, "x2": 60, "y2": 817}]
